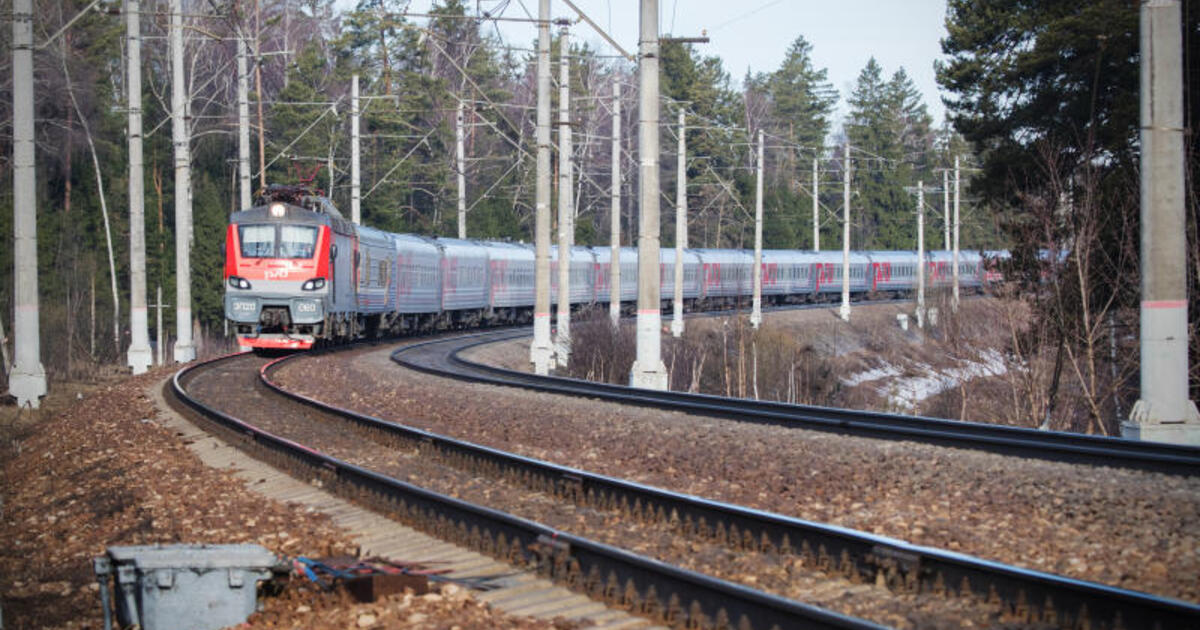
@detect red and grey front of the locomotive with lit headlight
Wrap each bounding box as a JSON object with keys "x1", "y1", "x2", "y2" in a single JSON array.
[{"x1": 224, "y1": 190, "x2": 353, "y2": 349}]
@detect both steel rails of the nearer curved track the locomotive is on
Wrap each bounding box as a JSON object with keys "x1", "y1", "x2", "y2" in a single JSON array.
[{"x1": 175, "y1": 343, "x2": 1200, "y2": 628}]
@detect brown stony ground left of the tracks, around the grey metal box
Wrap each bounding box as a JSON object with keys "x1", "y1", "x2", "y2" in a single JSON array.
[{"x1": 0, "y1": 370, "x2": 570, "y2": 630}]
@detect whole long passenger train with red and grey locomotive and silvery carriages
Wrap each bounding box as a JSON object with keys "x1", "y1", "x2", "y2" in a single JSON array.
[{"x1": 224, "y1": 185, "x2": 1003, "y2": 350}]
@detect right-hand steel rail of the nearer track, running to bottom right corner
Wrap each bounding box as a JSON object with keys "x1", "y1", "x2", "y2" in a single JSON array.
[{"x1": 250, "y1": 335, "x2": 1200, "y2": 628}]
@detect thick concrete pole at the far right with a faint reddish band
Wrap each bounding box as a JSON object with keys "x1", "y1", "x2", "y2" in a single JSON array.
[{"x1": 1121, "y1": 0, "x2": 1200, "y2": 444}]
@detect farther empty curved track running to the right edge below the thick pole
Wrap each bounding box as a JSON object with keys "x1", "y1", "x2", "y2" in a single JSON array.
[{"x1": 392, "y1": 330, "x2": 1200, "y2": 476}]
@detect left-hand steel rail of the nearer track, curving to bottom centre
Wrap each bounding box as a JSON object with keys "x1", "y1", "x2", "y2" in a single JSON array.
[{"x1": 170, "y1": 355, "x2": 882, "y2": 630}]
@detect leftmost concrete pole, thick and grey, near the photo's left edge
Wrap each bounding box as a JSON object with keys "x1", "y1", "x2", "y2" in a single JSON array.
[{"x1": 8, "y1": 0, "x2": 46, "y2": 409}]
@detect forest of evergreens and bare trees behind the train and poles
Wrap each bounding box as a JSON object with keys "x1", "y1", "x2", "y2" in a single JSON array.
[{"x1": 0, "y1": 0, "x2": 1200, "y2": 410}]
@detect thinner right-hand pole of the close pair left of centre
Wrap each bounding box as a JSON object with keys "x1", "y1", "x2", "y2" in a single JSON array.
[{"x1": 554, "y1": 26, "x2": 575, "y2": 367}]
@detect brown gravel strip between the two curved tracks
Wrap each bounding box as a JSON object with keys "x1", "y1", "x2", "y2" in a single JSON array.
[{"x1": 278, "y1": 309, "x2": 1200, "y2": 601}]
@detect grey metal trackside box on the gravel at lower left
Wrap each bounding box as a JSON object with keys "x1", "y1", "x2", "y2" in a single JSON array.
[{"x1": 95, "y1": 545, "x2": 278, "y2": 630}]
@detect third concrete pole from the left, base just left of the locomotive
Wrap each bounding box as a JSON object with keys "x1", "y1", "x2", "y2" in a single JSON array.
[{"x1": 170, "y1": 0, "x2": 194, "y2": 364}]
